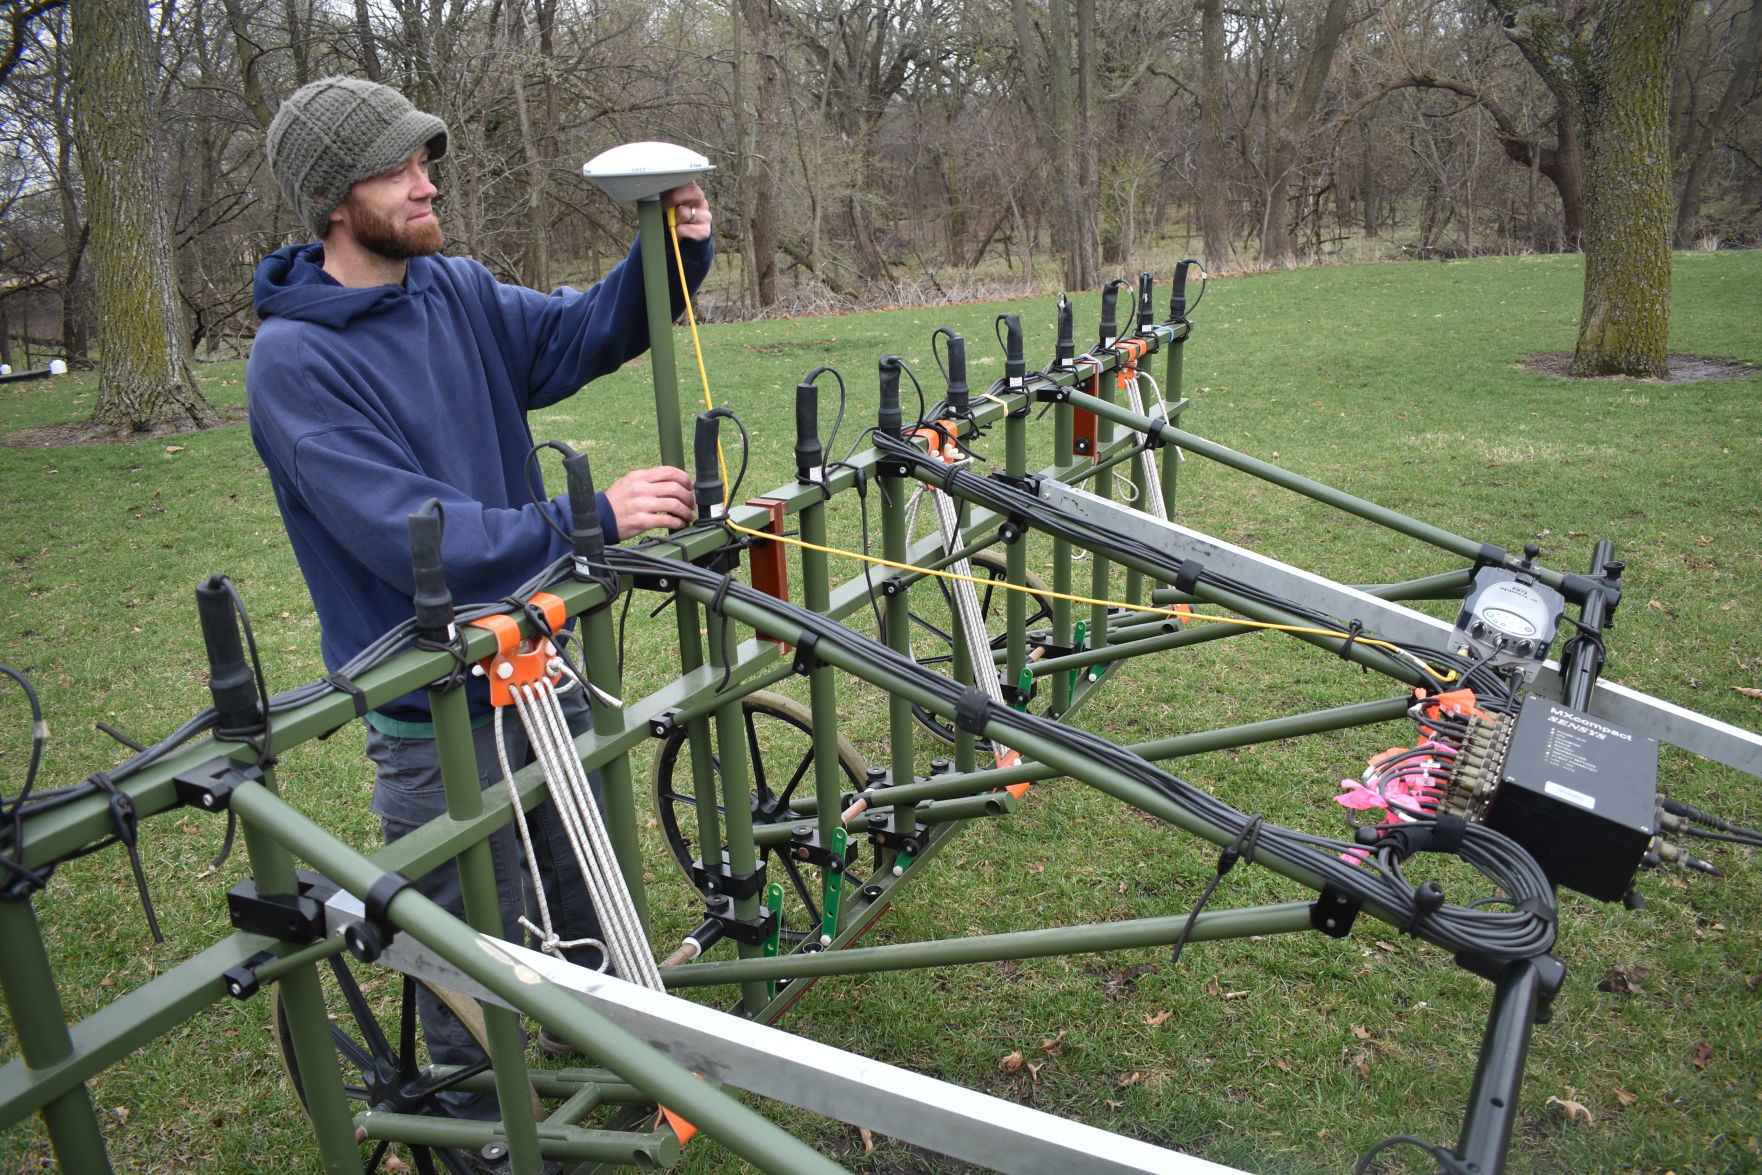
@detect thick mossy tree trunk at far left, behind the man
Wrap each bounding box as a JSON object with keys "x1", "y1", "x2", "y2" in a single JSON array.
[{"x1": 70, "y1": 0, "x2": 217, "y2": 432}]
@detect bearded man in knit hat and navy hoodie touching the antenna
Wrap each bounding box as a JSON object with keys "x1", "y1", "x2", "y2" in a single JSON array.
[{"x1": 245, "y1": 78, "x2": 712, "y2": 1117}]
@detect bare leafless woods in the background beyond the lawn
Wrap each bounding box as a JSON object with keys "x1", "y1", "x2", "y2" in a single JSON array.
[{"x1": 0, "y1": 0, "x2": 1762, "y2": 371}]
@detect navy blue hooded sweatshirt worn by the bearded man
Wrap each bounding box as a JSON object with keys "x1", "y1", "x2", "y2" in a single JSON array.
[{"x1": 245, "y1": 232, "x2": 712, "y2": 726}]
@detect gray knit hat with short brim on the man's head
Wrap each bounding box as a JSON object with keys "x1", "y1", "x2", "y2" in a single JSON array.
[{"x1": 268, "y1": 78, "x2": 446, "y2": 240}]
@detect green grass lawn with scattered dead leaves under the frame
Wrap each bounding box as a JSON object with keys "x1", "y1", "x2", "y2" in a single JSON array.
[{"x1": 0, "y1": 252, "x2": 1762, "y2": 1175}]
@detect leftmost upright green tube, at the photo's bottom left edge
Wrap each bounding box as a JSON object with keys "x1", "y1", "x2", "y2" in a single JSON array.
[{"x1": 0, "y1": 898, "x2": 111, "y2": 1173}]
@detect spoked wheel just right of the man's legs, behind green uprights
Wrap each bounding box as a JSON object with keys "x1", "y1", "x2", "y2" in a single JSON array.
[{"x1": 654, "y1": 689, "x2": 869, "y2": 942}]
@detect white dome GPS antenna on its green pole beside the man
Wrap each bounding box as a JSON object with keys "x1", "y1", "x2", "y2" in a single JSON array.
[{"x1": 581, "y1": 143, "x2": 715, "y2": 469}]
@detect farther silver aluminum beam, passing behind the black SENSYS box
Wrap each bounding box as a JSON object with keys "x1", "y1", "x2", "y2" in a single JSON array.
[{"x1": 1040, "y1": 481, "x2": 1762, "y2": 779}]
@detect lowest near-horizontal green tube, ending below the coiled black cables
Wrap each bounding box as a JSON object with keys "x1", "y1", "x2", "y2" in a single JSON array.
[{"x1": 664, "y1": 902, "x2": 1313, "y2": 988}]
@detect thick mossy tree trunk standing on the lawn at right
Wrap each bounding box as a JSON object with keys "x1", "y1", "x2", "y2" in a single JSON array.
[{"x1": 1572, "y1": 0, "x2": 1688, "y2": 379}]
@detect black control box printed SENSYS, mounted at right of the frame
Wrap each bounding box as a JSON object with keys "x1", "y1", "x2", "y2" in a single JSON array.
[{"x1": 1487, "y1": 694, "x2": 1658, "y2": 902}]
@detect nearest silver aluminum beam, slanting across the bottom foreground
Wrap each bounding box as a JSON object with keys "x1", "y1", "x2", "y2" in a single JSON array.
[{"x1": 326, "y1": 891, "x2": 1246, "y2": 1175}]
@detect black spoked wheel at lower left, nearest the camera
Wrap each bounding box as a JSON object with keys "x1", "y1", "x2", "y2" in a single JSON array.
[{"x1": 270, "y1": 955, "x2": 537, "y2": 1175}]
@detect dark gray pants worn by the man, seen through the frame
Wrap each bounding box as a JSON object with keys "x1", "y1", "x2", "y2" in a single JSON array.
[{"x1": 366, "y1": 689, "x2": 603, "y2": 1119}]
